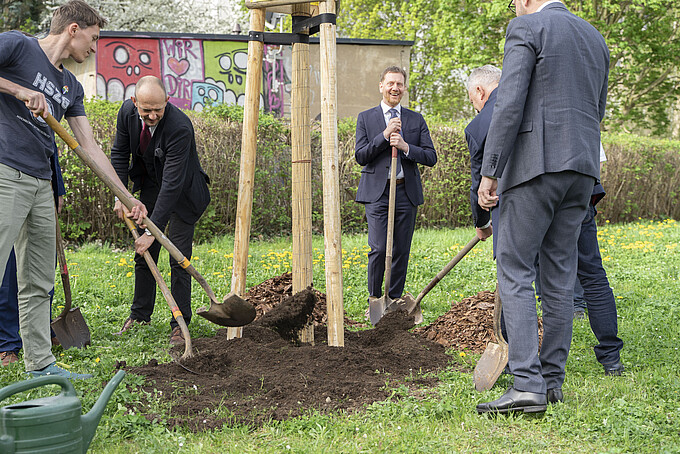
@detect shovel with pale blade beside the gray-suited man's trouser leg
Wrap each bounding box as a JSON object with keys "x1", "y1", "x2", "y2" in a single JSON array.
[{"x1": 472, "y1": 288, "x2": 508, "y2": 391}]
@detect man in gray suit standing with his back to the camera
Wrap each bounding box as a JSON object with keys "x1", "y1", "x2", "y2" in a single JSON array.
[{"x1": 477, "y1": 0, "x2": 609, "y2": 413}]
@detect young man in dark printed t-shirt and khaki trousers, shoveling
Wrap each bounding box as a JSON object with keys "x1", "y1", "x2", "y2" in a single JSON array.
[{"x1": 0, "y1": 0, "x2": 147, "y2": 378}]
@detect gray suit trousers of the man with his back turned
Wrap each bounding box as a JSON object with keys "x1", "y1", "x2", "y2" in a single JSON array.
[{"x1": 496, "y1": 171, "x2": 594, "y2": 393}]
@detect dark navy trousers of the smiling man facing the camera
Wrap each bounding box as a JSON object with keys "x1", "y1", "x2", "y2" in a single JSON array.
[{"x1": 366, "y1": 183, "x2": 418, "y2": 299}]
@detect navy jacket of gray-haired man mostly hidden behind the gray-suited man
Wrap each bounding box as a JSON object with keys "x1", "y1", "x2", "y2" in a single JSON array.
[{"x1": 465, "y1": 88, "x2": 498, "y2": 227}]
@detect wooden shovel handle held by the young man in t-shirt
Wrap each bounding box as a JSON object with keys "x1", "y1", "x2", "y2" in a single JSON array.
[{"x1": 45, "y1": 114, "x2": 218, "y2": 303}]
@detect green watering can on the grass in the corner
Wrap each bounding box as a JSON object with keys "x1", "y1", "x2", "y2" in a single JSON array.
[{"x1": 0, "y1": 370, "x2": 125, "y2": 454}]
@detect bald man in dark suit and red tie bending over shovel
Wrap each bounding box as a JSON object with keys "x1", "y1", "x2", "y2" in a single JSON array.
[{"x1": 111, "y1": 76, "x2": 210, "y2": 345}]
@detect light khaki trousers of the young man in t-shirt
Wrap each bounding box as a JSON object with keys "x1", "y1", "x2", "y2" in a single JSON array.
[{"x1": 0, "y1": 164, "x2": 56, "y2": 370}]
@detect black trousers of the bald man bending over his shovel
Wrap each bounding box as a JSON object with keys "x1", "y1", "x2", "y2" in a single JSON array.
[{"x1": 130, "y1": 189, "x2": 195, "y2": 328}]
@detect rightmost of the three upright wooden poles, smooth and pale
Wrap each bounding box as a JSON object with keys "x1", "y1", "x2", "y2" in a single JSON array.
[{"x1": 319, "y1": 0, "x2": 345, "y2": 347}]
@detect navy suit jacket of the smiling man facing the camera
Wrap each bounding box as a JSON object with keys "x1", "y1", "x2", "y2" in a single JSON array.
[{"x1": 354, "y1": 106, "x2": 437, "y2": 206}]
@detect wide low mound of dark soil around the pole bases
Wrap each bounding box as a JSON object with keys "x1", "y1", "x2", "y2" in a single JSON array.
[{"x1": 129, "y1": 310, "x2": 449, "y2": 431}]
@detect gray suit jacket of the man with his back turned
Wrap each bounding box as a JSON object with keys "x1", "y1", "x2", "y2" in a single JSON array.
[{"x1": 482, "y1": 3, "x2": 609, "y2": 193}]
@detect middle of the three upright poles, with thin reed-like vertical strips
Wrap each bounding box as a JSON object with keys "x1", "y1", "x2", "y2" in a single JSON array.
[{"x1": 291, "y1": 3, "x2": 314, "y2": 344}]
